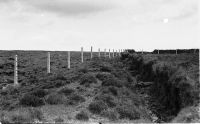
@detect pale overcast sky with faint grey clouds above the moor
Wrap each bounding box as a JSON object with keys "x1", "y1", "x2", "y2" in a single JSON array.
[{"x1": 0, "y1": 0, "x2": 199, "y2": 51}]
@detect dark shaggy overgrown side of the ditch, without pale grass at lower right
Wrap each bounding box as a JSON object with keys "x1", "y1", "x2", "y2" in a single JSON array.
[{"x1": 121, "y1": 53, "x2": 199, "y2": 121}]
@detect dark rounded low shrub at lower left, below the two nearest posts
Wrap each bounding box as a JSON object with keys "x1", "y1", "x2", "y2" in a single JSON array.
[{"x1": 19, "y1": 94, "x2": 45, "y2": 107}]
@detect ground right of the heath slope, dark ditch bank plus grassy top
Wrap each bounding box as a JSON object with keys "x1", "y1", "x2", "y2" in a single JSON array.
[{"x1": 121, "y1": 53, "x2": 200, "y2": 122}]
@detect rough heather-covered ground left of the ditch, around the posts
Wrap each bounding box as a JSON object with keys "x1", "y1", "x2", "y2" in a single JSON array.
[{"x1": 0, "y1": 51, "x2": 152, "y2": 123}]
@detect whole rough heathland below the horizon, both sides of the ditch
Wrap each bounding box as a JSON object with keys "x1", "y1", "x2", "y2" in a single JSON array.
[{"x1": 0, "y1": 51, "x2": 199, "y2": 123}]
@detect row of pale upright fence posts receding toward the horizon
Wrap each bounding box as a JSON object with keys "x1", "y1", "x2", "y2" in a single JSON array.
[{"x1": 14, "y1": 47, "x2": 125, "y2": 85}]
